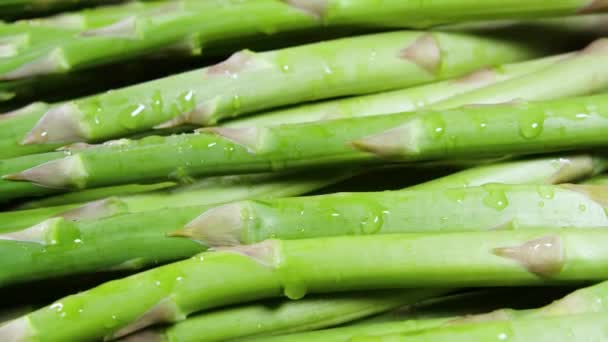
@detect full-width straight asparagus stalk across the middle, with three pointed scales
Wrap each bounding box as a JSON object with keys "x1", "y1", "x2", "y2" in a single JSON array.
[{"x1": 3, "y1": 95, "x2": 608, "y2": 195}]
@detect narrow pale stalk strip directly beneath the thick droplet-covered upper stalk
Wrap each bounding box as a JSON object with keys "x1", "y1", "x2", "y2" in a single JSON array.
[{"x1": 222, "y1": 55, "x2": 565, "y2": 127}]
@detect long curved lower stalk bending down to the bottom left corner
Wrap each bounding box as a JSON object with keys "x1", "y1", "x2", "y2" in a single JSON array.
[{"x1": 0, "y1": 229, "x2": 608, "y2": 341}]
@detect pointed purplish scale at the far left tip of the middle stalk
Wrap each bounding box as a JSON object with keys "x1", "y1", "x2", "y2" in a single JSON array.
[{"x1": 2, "y1": 157, "x2": 86, "y2": 189}]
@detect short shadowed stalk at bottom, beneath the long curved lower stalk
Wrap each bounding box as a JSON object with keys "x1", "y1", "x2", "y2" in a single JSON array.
[{"x1": 121, "y1": 289, "x2": 442, "y2": 342}]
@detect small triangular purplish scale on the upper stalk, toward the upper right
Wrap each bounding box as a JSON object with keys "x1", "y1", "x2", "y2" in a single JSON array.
[{"x1": 399, "y1": 33, "x2": 441, "y2": 74}]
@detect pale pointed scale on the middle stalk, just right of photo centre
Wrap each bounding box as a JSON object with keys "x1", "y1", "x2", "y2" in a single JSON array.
[{"x1": 351, "y1": 124, "x2": 418, "y2": 157}]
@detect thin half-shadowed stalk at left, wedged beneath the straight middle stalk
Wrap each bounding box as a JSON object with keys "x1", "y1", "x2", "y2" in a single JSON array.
[{"x1": 0, "y1": 172, "x2": 353, "y2": 232}]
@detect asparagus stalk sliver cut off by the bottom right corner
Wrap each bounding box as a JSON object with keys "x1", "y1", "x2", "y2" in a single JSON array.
[{"x1": 350, "y1": 312, "x2": 608, "y2": 342}]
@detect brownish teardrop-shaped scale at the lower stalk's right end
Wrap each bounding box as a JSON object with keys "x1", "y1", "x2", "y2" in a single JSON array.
[{"x1": 494, "y1": 235, "x2": 564, "y2": 277}]
